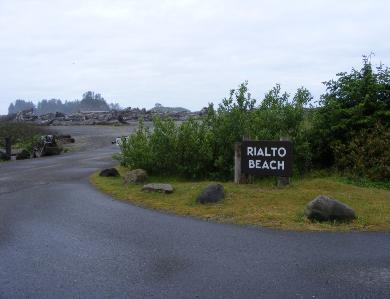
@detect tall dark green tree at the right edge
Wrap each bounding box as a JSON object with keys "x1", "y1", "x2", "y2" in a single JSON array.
[{"x1": 311, "y1": 57, "x2": 390, "y2": 174}]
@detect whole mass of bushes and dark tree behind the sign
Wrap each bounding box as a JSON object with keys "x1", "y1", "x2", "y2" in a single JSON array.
[{"x1": 119, "y1": 57, "x2": 390, "y2": 182}]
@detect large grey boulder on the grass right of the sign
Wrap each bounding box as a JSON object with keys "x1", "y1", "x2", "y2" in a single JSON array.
[{"x1": 305, "y1": 195, "x2": 356, "y2": 221}]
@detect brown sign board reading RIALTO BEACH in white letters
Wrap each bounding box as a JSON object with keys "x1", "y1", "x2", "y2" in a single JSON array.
[{"x1": 241, "y1": 141, "x2": 293, "y2": 177}]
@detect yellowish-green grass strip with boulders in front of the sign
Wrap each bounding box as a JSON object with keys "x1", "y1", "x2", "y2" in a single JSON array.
[{"x1": 91, "y1": 168, "x2": 390, "y2": 231}]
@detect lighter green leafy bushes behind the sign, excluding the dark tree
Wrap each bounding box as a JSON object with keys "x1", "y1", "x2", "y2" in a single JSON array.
[{"x1": 120, "y1": 82, "x2": 311, "y2": 179}]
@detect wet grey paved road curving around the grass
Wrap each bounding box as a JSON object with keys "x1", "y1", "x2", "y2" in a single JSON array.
[{"x1": 0, "y1": 128, "x2": 390, "y2": 298}]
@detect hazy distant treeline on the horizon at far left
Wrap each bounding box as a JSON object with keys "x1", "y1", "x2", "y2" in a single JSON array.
[{"x1": 8, "y1": 91, "x2": 121, "y2": 115}]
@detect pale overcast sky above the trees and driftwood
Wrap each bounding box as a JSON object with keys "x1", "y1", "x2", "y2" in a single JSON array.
[{"x1": 0, "y1": 0, "x2": 390, "y2": 114}]
